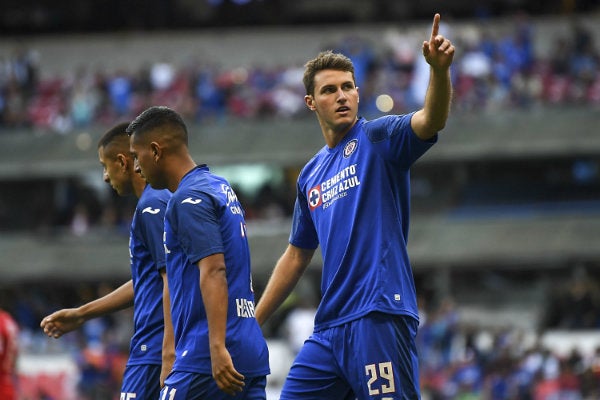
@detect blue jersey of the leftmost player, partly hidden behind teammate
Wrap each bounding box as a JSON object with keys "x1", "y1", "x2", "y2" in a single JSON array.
[{"x1": 127, "y1": 185, "x2": 171, "y2": 365}]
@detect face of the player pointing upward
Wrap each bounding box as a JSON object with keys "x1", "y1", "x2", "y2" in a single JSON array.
[{"x1": 306, "y1": 69, "x2": 358, "y2": 131}]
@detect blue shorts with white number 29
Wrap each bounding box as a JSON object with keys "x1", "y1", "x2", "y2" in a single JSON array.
[{"x1": 280, "y1": 313, "x2": 421, "y2": 400}]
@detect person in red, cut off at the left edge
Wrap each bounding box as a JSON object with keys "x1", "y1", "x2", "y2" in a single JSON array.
[{"x1": 0, "y1": 308, "x2": 19, "y2": 400}]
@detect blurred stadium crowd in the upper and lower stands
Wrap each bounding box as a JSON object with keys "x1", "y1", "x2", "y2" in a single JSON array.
[{"x1": 0, "y1": 10, "x2": 600, "y2": 400}]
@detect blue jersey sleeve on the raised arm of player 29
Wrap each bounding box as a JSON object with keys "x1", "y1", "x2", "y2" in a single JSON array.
[{"x1": 365, "y1": 113, "x2": 437, "y2": 168}]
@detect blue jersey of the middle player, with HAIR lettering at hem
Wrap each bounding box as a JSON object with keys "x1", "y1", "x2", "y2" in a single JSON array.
[{"x1": 164, "y1": 165, "x2": 269, "y2": 377}]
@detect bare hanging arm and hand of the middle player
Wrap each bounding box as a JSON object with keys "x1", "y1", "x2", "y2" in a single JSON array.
[{"x1": 198, "y1": 253, "x2": 244, "y2": 395}]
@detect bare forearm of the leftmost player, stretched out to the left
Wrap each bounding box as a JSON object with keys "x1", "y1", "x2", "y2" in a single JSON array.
[{"x1": 40, "y1": 280, "x2": 133, "y2": 338}]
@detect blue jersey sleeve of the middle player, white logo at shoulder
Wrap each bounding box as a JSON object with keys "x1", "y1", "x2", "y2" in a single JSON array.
[{"x1": 176, "y1": 192, "x2": 225, "y2": 264}]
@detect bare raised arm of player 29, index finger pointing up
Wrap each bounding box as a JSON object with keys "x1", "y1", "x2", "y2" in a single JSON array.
[{"x1": 411, "y1": 14, "x2": 454, "y2": 140}]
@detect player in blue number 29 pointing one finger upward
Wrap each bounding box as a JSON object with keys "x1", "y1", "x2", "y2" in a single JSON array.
[{"x1": 256, "y1": 14, "x2": 454, "y2": 400}]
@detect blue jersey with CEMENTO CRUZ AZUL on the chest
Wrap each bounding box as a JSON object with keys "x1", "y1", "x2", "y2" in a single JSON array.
[{"x1": 290, "y1": 114, "x2": 437, "y2": 331}]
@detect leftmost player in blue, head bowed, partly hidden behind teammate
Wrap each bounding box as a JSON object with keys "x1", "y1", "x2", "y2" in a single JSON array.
[{"x1": 40, "y1": 123, "x2": 175, "y2": 400}]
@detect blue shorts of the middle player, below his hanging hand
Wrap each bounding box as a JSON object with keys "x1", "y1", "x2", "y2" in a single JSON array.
[{"x1": 159, "y1": 371, "x2": 267, "y2": 400}]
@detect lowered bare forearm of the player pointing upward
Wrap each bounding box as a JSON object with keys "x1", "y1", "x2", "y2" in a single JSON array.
[{"x1": 255, "y1": 244, "x2": 315, "y2": 325}]
